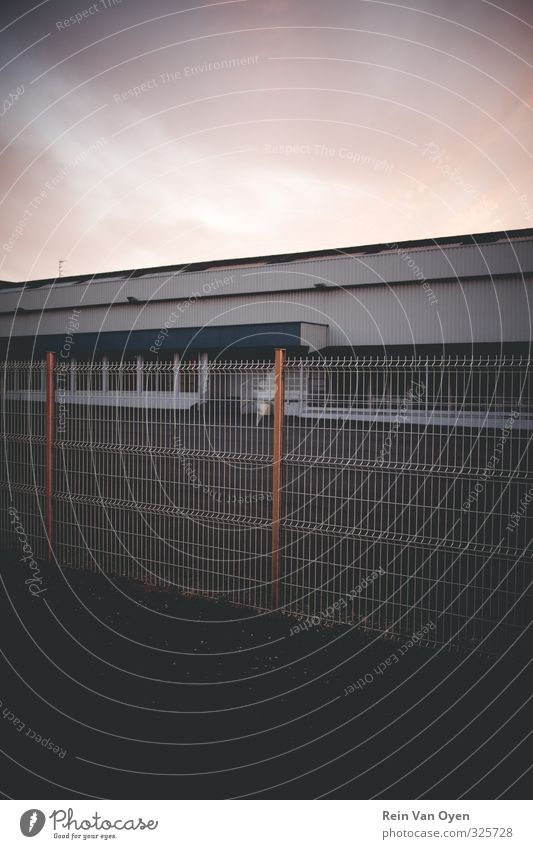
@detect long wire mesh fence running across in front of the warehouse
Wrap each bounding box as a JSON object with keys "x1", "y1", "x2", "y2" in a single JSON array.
[{"x1": 1, "y1": 357, "x2": 533, "y2": 651}]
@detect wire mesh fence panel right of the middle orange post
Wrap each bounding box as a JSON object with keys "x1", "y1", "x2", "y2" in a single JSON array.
[{"x1": 283, "y1": 358, "x2": 533, "y2": 649}]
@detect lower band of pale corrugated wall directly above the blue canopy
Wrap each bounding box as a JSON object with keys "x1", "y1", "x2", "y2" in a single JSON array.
[{"x1": 4, "y1": 275, "x2": 533, "y2": 346}]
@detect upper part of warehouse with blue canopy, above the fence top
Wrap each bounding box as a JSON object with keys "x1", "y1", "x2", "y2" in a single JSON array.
[{"x1": 0, "y1": 229, "x2": 533, "y2": 361}]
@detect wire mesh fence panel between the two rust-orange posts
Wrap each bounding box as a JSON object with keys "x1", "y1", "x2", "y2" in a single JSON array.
[{"x1": 51, "y1": 363, "x2": 272, "y2": 609}]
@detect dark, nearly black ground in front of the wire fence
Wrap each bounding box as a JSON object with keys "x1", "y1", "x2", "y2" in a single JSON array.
[{"x1": 0, "y1": 556, "x2": 531, "y2": 799}]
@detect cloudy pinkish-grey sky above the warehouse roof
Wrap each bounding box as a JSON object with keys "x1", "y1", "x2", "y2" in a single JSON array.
[{"x1": 0, "y1": 0, "x2": 533, "y2": 281}]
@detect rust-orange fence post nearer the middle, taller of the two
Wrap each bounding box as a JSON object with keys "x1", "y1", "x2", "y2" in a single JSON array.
[{"x1": 272, "y1": 348, "x2": 285, "y2": 610}]
